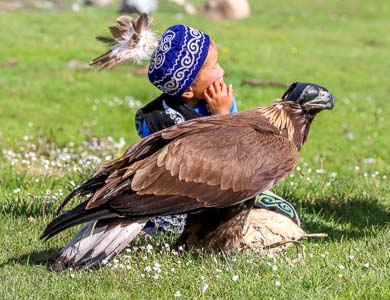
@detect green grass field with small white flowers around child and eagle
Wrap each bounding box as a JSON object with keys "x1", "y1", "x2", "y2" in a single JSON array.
[{"x1": 0, "y1": 0, "x2": 390, "y2": 299}]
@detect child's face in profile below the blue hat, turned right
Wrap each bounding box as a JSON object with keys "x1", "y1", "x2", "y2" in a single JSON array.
[{"x1": 191, "y1": 40, "x2": 225, "y2": 99}]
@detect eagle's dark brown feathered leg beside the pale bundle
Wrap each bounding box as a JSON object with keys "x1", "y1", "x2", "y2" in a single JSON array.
[{"x1": 178, "y1": 198, "x2": 254, "y2": 252}]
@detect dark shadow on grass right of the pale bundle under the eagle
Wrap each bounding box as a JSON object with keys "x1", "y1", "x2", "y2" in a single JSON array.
[{"x1": 302, "y1": 198, "x2": 390, "y2": 240}]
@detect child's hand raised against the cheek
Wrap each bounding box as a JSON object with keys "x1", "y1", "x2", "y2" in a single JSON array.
[{"x1": 204, "y1": 80, "x2": 233, "y2": 115}]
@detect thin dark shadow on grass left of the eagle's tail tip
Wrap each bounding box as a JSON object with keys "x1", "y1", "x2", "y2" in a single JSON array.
[{"x1": 0, "y1": 248, "x2": 58, "y2": 268}]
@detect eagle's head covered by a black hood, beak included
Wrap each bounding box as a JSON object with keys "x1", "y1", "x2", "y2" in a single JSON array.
[{"x1": 282, "y1": 82, "x2": 334, "y2": 115}]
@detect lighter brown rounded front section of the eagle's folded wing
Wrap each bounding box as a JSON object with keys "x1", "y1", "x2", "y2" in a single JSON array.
[{"x1": 131, "y1": 127, "x2": 298, "y2": 207}]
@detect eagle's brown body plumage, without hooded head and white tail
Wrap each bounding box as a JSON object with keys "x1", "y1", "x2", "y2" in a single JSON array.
[{"x1": 42, "y1": 90, "x2": 333, "y2": 266}]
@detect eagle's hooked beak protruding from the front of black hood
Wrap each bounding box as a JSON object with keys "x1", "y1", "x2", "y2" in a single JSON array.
[{"x1": 298, "y1": 86, "x2": 334, "y2": 113}]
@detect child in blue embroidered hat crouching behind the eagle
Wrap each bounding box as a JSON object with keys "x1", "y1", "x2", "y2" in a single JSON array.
[{"x1": 135, "y1": 24, "x2": 300, "y2": 233}]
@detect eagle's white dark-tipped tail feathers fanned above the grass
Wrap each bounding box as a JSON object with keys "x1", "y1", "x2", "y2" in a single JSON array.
[{"x1": 50, "y1": 218, "x2": 146, "y2": 272}]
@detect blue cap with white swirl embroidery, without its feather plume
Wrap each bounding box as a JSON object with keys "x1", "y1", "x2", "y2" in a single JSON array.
[{"x1": 148, "y1": 24, "x2": 210, "y2": 96}]
